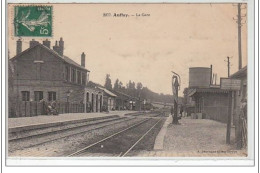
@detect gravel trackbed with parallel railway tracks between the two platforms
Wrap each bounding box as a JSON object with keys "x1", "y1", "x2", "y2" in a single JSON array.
[{"x1": 8, "y1": 113, "x2": 164, "y2": 157}]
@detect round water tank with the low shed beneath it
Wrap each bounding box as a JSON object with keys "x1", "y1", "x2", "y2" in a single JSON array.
[{"x1": 188, "y1": 66, "x2": 228, "y2": 123}]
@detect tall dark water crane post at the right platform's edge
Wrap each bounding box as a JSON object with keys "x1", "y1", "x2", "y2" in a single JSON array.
[{"x1": 171, "y1": 71, "x2": 181, "y2": 124}]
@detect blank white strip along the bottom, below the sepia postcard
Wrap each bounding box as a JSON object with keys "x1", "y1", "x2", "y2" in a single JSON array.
[{"x1": 7, "y1": 157, "x2": 254, "y2": 166}]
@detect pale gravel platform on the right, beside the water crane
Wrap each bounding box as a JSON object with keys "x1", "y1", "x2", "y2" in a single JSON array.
[{"x1": 145, "y1": 116, "x2": 243, "y2": 157}]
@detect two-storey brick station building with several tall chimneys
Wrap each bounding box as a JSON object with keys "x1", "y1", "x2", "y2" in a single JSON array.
[{"x1": 10, "y1": 38, "x2": 103, "y2": 116}]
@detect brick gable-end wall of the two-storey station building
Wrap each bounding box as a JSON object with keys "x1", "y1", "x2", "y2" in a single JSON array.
[{"x1": 12, "y1": 45, "x2": 90, "y2": 103}]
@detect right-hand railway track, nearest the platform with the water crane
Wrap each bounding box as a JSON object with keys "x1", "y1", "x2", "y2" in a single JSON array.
[{"x1": 67, "y1": 118, "x2": 164, "y2": 157}]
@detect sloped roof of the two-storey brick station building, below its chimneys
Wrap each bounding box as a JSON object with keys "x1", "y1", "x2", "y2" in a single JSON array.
[{"x1": 11, "y1": 43, "x2": 89, "y2": 72}]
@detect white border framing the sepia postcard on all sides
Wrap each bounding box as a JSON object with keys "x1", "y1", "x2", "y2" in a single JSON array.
[{"x1": 1, "y1": 0, "x2": 258, "y2": 168}]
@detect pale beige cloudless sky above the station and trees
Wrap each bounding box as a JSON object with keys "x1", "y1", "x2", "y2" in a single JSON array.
[{"x1": 8, "y1": 4, "x2": 247, "y2": 95}]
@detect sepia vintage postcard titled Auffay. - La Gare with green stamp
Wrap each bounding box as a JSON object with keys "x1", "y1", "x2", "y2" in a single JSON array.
[{"x1": 6, "y1": 2, "x2": 255, "y2": 166}]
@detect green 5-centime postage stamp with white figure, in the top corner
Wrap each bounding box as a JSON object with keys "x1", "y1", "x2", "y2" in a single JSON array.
[{"x1": 14, "y1": 6, "x2": 52, "y2": 37}]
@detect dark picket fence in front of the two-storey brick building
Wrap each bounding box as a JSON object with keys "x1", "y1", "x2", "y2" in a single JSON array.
[{"x1": 9, "y1": 101, "x2": 84, "y2": 118}]
